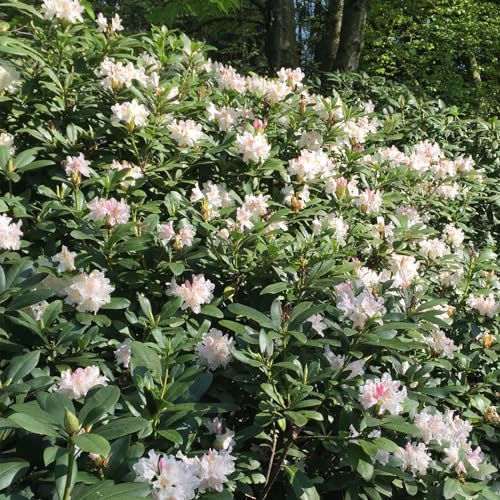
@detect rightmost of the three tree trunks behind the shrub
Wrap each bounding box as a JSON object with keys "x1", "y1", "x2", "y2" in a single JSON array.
[{"x1": 335, "y1": 0, "x2": 368, "y2": 71}]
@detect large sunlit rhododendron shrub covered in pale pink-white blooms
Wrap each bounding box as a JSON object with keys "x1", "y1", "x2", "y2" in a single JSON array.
[{"x1": 0, "y1": 0, "x2": 500, "y2": 500}]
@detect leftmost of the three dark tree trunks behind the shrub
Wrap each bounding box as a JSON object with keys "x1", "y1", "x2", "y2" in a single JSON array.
[{"x1": 266, "y1": 0, "x2": 299, "y2": 73}]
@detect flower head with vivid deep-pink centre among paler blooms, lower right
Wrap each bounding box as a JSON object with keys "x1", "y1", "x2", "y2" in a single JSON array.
[{"x1": 359, "y1": 373, "x2": 407, "y2": 415}]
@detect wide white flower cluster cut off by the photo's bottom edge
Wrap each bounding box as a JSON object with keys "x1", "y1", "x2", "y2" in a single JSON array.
[{"x1": 134, "y1": 450, "x2": 236, "y2": 500}]
